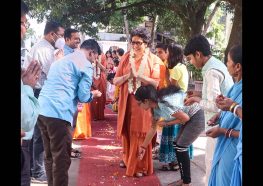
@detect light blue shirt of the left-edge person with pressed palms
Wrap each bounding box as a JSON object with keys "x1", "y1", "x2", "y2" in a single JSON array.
[{"x1": 21, "y1": 80, "x2": 39, "y2": 140}]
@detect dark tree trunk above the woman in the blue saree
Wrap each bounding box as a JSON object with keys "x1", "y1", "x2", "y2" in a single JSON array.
[{"x1": 225, "y1": 0, "x2": 242, "y2": 63}]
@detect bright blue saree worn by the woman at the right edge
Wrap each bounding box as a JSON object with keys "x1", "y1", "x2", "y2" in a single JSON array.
[{"x1": 208, "y1": 80, "x2": 242, "y2": 186}]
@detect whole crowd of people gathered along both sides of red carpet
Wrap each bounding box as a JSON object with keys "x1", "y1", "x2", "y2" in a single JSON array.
[{"x1": 21, "y1": 1, "x2": 242, "y2": 186}]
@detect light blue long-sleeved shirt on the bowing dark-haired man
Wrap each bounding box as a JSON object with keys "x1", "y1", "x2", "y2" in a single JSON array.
[{"x1": 38, "y1": 50, "x2": 93, "y2": 123}]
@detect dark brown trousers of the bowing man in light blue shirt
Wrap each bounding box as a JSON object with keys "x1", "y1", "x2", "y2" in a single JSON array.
[{"x1": 37, "y1": 115, "x2": 72, "y2": 186}]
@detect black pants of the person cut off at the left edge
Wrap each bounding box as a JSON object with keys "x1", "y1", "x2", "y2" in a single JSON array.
[{"x1": 21, "y1": 140, "x2": 31, "y2": 186}]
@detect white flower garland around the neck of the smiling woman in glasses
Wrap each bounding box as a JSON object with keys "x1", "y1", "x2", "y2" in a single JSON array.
[{"x1": 128, "y1": 48, "x2": 150, "y2": 94}]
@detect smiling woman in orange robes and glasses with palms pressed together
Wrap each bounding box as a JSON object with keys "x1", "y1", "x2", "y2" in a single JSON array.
[{"x1": 113, "y1": 27, "x2": 160, "y2": 177}]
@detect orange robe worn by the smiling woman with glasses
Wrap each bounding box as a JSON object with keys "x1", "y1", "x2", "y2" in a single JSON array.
[{"x1": 115, "y1": 52, "x2": 160, "y2": 176}]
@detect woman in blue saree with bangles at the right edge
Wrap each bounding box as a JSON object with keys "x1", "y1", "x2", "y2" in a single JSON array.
[{"x1": 206, "y1": 45, "x2": 242, "y2": 186}]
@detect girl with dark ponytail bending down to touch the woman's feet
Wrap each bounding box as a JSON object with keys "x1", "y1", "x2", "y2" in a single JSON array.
[{"x1": 135, "y1": 85, "x2": 205, "y2": 186}]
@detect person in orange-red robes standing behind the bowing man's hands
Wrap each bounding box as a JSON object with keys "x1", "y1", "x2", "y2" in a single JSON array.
[{"x1": 90, "y1": 54, "x2": 107, "y2": 120}]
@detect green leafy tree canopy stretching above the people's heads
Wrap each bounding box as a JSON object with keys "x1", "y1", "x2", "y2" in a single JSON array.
[{"x1": 25, "y1": 0, "x2": 242, "y2": 50}]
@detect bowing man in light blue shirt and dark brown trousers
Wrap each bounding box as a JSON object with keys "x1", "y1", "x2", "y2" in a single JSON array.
[{"x1": 38, "y1": 39, "x2": 101, "y2": 186}]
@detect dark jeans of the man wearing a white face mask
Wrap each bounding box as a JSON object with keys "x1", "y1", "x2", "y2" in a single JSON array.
[{"x1": 31, "y1": 89, "x2": 46, "y2": 179}]
